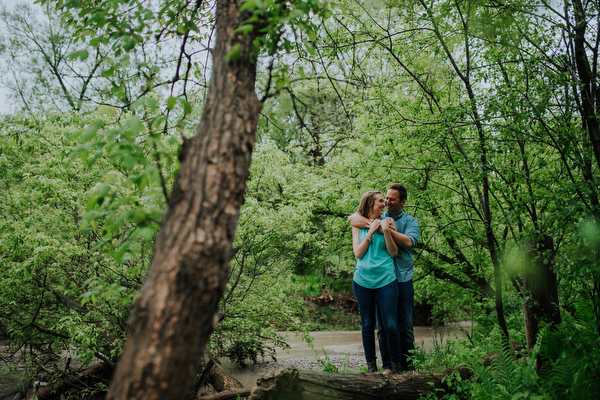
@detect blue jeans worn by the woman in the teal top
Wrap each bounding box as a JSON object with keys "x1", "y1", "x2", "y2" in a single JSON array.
[{"x1": 352, "y1": 281, "x2": 401, "y2": 363}]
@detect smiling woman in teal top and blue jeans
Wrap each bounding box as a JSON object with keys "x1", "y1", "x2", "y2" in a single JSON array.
[{"x1": 352, "y1": 190, "x2": 401, "y2": 374}]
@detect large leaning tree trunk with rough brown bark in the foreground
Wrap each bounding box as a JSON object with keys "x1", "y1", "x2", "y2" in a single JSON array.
[{"x1": 108, "y1": 0, "x2": 260, "y2": 400}]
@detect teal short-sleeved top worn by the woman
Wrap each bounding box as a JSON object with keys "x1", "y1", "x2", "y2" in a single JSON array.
[{"x1": 354, "y1": 229, "x2": 396, "y2": 289}]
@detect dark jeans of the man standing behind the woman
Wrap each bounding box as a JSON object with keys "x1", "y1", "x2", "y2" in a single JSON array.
[{"x1": 377, "y1": 280, "x2": 415, "y2": 371}]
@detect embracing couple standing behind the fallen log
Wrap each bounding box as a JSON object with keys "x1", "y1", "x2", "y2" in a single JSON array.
[{"x1": 348, "y1": 184, "x2": 420, "y2": 374}]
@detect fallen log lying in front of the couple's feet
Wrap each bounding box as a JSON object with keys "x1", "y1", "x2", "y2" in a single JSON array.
[{"x1": 249, "y1": 368, "x2": 472, "y2": 400}]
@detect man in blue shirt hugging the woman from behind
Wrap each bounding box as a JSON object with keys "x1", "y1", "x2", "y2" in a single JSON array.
[{"x1": 348, "y1": 183, "x2": 420, "y2": 374}]
